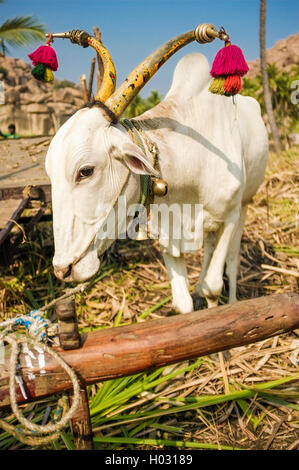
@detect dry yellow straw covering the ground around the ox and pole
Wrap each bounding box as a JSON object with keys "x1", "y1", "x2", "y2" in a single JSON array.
[{"x1": 0, "y1": 149, "x2": 299, "y2": 449}]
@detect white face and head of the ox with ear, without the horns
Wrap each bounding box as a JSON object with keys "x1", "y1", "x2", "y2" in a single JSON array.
[{"x1": 46, "y1": 107, "x2": 156, "y2": 281}]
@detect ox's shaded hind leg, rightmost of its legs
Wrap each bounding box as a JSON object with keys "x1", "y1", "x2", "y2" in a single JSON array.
[{"x1": 225, "y1": 206, "x2": 247, "y2": 303}]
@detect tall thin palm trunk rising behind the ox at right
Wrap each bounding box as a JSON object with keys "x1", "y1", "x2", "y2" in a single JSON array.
[{"x1": 260, "y1": 0, "x2": 281, "y2": 152}]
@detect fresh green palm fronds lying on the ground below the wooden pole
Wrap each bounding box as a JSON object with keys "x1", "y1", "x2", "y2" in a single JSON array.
[{"x1": 90, "y1": 370, "x2": 299, "y2": 450}]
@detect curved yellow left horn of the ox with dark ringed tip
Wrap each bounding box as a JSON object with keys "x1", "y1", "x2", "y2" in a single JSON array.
[{"x1": 46, "y1": 29, "x2": 116, "y2": 102}]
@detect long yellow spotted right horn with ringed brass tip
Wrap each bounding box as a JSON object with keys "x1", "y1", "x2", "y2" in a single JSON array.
[{"x1": 105, "y1": 24, "x2": 219, "y2": 117}]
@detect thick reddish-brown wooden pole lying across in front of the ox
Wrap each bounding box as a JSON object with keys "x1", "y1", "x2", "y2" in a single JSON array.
[{"x1": 0, "y1": 293, "x2": 299, "y2": 409}]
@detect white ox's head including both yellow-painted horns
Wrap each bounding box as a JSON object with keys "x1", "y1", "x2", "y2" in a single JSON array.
[{"x1": 46, "y1": 25, "x2": 218, "y2": 281}]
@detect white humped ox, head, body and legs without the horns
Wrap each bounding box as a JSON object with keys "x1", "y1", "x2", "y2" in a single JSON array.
[{"x1": 46, "y1": 53, "x2": 268, "y2": 313}]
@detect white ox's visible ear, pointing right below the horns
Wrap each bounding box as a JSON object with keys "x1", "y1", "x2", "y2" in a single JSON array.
[{"x1": 121, "y1": 142, "x2": 159, "y2": 176}]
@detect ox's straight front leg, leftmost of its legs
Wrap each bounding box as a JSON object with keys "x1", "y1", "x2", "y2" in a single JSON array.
[{"x1": 163, "y1": 253, "x2": 193, "y2": 313}]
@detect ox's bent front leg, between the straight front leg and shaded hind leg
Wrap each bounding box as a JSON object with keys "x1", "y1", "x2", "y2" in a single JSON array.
[{"x1": 202, "y1": 210, "x2": 240, "y2": 308}]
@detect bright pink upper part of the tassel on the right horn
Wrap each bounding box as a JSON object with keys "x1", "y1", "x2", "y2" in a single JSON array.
[{"x1": 210, "y1": 42, "x2": 249, "y2": 77}]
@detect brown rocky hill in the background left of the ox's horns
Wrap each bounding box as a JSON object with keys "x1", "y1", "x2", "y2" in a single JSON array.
[{"x1": 0, "y1": 57, "x2": 83, "y2": 136}]
